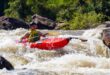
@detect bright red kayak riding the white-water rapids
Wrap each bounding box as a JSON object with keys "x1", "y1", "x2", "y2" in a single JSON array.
[{"x1": 30, "y1": 38, "x2": 70, "y2": 50}]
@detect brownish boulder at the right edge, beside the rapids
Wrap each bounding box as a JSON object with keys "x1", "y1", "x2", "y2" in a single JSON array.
[{"x1": 102, "y1": 29, "x2": 110, "y2": 48}]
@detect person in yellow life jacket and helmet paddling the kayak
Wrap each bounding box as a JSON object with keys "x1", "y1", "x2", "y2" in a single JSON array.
[{"x1": 20, "y1": 23, "x2": 48, "y2": 42}]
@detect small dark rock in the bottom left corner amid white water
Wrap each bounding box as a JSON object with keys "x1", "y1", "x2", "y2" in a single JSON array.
[{"x1": 0, "y1": 56, "x2": 14, "y2": 70}]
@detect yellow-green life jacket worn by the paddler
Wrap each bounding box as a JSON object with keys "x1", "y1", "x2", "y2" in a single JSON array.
[{"x1": 28, "y1": 29, "x2": 40, "y2": 42}]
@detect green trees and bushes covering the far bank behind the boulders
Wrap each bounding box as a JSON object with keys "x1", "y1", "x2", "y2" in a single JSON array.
[{"x1": 0, "y1": 0, "x2": 110, "y2": 29}]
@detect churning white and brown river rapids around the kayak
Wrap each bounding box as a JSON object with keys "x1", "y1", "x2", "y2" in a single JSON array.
[{"x1": 0, "y1": 28, "x2": 110, "y2": 75}]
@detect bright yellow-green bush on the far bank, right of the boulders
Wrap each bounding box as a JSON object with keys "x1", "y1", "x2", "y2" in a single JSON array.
[{"x1": 69, "y1": 11, "x2": 103, "y2": 30}]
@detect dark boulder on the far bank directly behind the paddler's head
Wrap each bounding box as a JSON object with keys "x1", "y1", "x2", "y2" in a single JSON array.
[{"x1": 31, "y1": 14, "x2": 57, "y2": 29}]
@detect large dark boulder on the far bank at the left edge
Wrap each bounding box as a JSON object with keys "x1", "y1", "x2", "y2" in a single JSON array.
[{"x1": 0, "y1": 16, "x2": 29, "y2": 30}]
